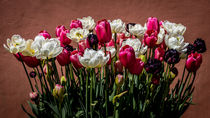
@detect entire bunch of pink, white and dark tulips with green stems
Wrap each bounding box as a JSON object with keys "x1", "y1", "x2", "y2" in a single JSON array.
[{"x1": 4, "y1": 17, "x2": 206, "y2": 118}]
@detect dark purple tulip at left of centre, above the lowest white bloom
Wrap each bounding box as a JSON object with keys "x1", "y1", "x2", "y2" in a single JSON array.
[{"x1": 86, "y1": 34, "x2": 98, "y2": 50}]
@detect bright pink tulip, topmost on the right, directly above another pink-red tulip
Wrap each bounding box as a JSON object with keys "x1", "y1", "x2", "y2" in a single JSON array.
[{"x1": 147, "y1": 17, "x2": 160, "y2": 34}]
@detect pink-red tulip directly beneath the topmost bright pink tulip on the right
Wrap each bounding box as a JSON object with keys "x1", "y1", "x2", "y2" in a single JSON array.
[{"x1": 143, "y1": 32, "x2": 158, "y2": 48}]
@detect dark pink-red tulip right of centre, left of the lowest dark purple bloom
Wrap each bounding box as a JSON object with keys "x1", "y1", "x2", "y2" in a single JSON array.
[{"x1": 128, "y1": 59, "x2": 144, "y2": 75}]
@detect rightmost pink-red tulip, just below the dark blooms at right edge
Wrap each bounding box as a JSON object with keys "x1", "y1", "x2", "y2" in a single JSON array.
[{"x1": 186, "y1": 53, "x2": 202, "y2": 72}]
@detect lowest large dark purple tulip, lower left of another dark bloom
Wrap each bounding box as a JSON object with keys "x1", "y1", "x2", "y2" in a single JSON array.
[{"x1": 144, "y1": 59, "x2": 162, "y2": 75}]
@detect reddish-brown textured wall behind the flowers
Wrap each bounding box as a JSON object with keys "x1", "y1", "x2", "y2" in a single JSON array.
[{"x1": 0, "y1": 0, "x2": 210, "y2": 118}]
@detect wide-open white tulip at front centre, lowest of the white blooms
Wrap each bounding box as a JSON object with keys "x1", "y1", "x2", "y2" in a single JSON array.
[{"x1": 79, "y1": 48, "x2": 110, "y2": 68}]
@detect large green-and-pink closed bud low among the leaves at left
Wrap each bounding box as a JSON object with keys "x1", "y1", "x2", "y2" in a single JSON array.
[{"x1": 53, "y1": 84, "x2": 65, "y2": 102}]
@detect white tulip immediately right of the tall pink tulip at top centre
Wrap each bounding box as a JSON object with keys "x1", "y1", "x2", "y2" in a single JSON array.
[{"x1": 109, "y1": 19, "x2": 125, "y2": 33}]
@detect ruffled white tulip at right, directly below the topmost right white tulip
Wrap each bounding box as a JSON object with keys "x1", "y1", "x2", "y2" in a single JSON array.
[{"x1": 165, "y1": 35, "x2": 189, "y2": 53}]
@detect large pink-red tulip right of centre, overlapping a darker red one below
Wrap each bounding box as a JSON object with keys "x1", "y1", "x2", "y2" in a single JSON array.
[{"x1": 119, "y1": 45, "x2": 136, "y2": 68}]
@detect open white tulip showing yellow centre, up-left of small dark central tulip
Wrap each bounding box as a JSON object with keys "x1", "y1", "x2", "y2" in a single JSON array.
[{"x1": 66, "y1": 28, "x2": 89, "y2": 43}]
